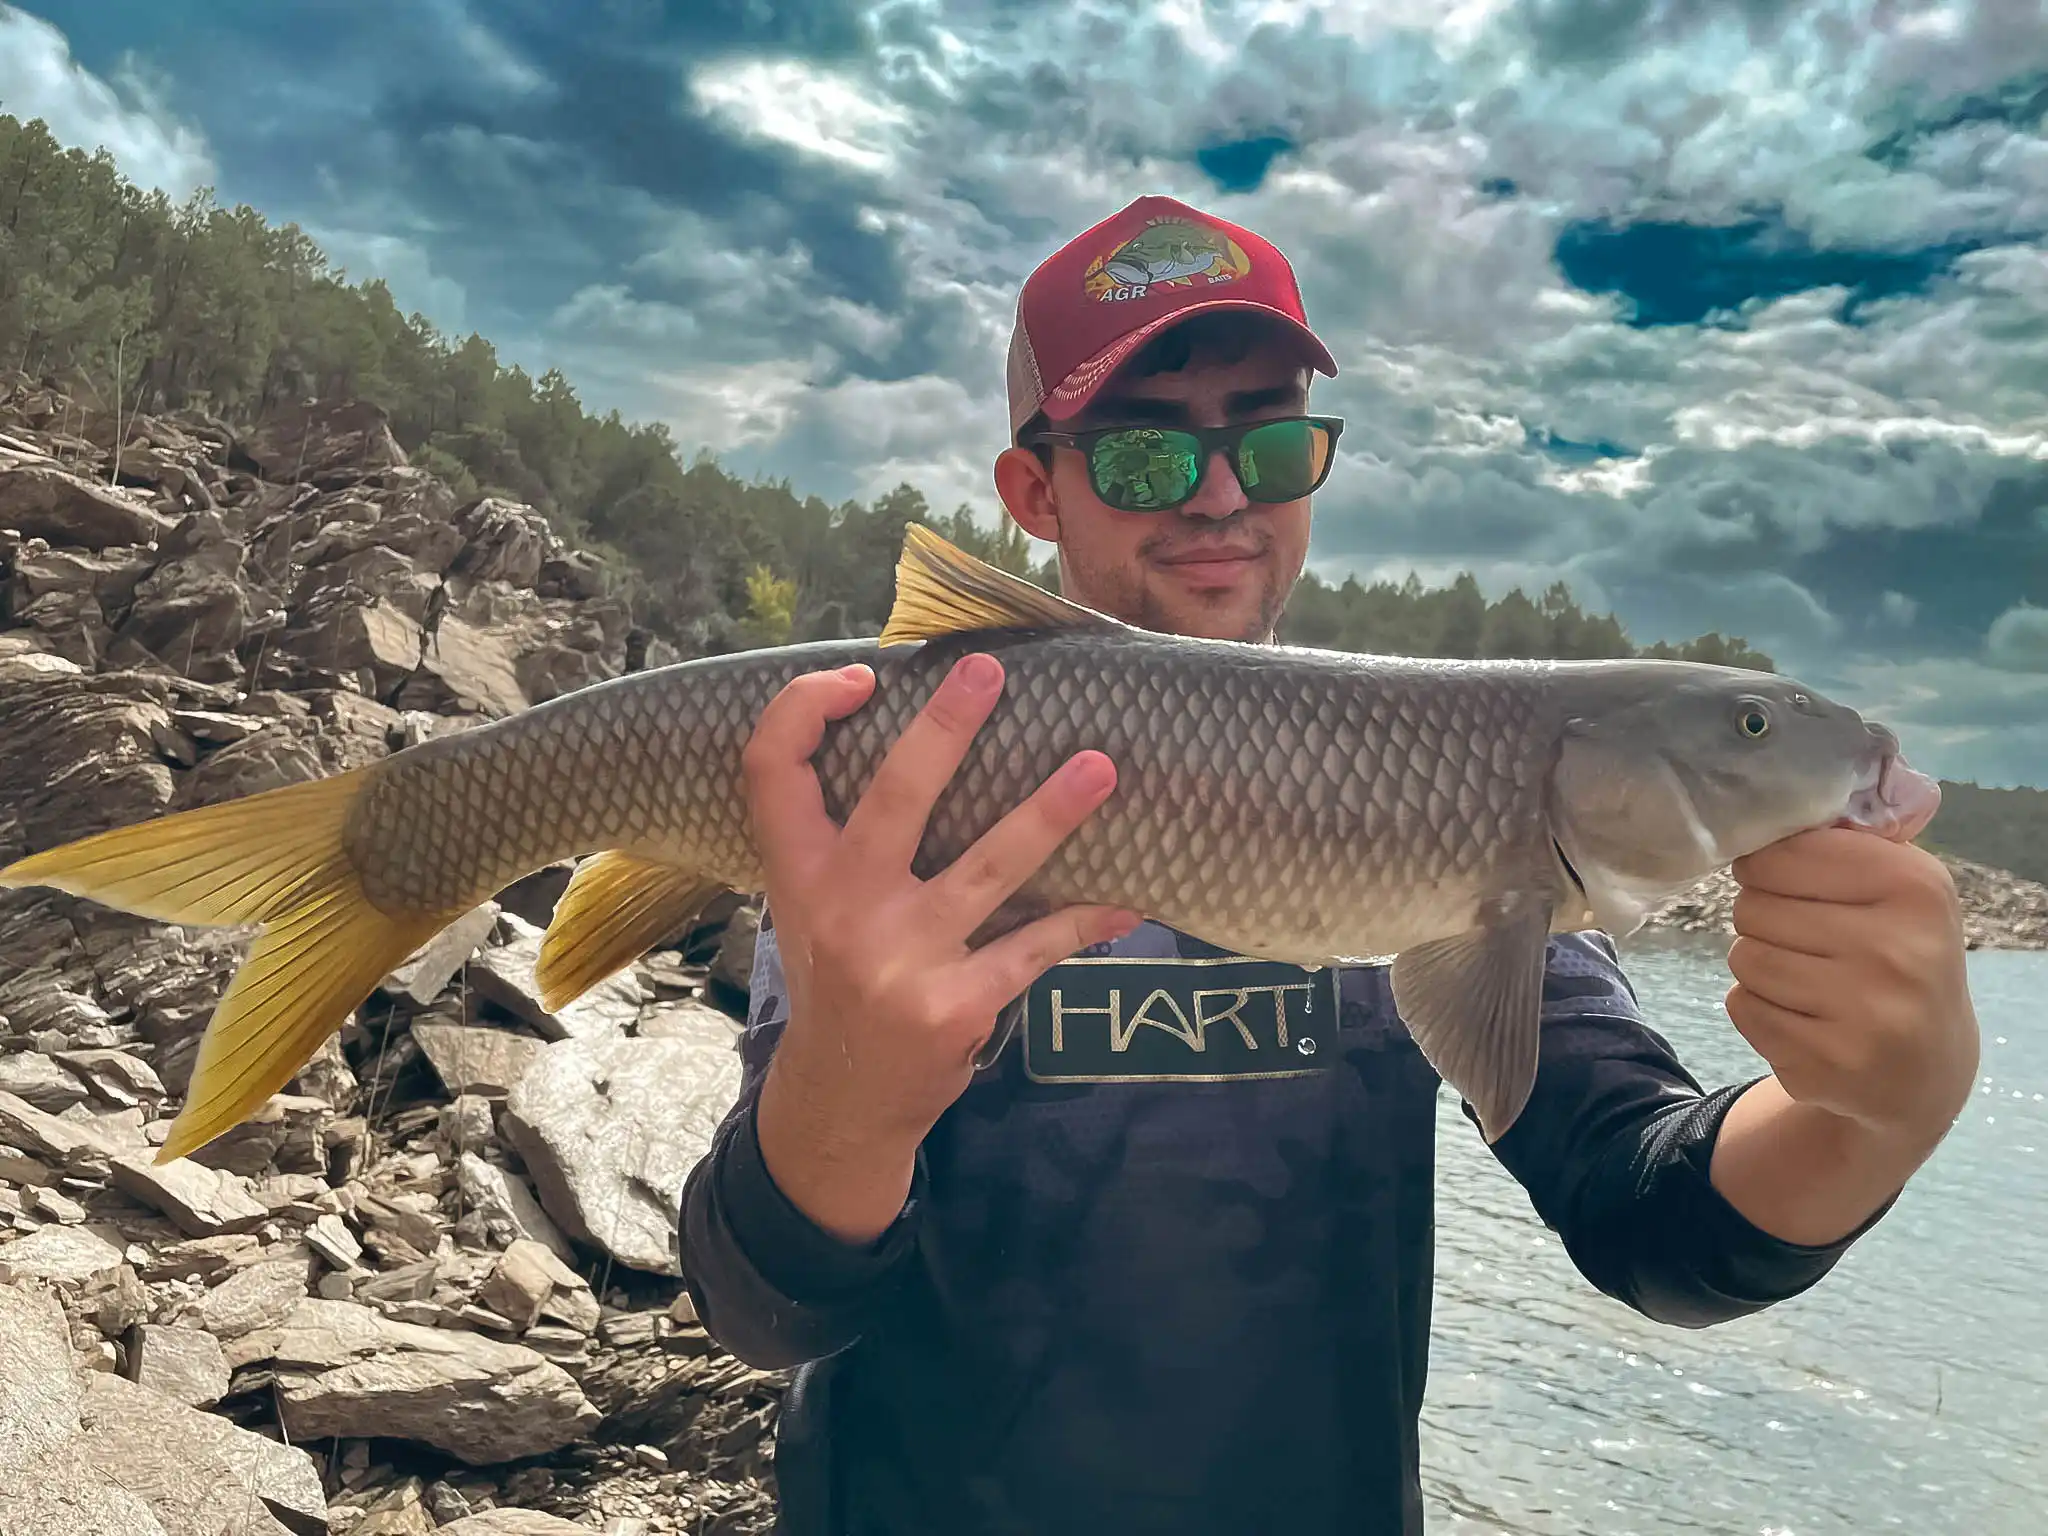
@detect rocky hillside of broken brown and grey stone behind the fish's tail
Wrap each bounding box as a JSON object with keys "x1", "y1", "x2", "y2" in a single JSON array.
[{"x1": 0, "y1": 375, "x2": 780, "y2": 1536}]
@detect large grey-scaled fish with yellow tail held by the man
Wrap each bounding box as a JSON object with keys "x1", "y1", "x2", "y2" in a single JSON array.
[{"x1": 0, "y1": 526, "x2": 1939, "y2": 1159}]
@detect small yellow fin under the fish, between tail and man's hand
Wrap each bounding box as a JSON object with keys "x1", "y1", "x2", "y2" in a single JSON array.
[{"x1": 532, "y1": 850, "x2": 725, "y2": 1014}]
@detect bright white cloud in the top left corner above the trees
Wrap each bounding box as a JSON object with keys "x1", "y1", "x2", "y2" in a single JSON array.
[{"x1": 0, "y1": 4, "x2": 215, "y2": 199}]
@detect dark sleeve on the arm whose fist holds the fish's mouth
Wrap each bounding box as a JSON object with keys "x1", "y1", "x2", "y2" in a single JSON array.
[{"x1": 1466, "y1": 932, "x2": 1890, "y2": 1327}]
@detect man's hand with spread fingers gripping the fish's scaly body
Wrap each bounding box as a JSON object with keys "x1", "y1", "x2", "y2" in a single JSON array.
[{"x1": 743, "y1": 653, "x2": 1139, "y2": 1243}]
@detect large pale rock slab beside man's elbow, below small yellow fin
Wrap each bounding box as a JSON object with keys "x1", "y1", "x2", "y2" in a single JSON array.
[{"x1": 504, "y1": 1038, "x2": 739, "y2": 1276}]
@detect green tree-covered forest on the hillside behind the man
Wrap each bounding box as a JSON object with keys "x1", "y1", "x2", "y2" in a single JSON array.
[{"x1": 0, "y1": 102, "x2": 1772, "y2": 670}]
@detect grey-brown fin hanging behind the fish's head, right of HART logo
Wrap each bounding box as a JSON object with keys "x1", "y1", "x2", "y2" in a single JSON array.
[{"x1": 1391, "y1": 897, "x2": 1550, "y2": 1145}]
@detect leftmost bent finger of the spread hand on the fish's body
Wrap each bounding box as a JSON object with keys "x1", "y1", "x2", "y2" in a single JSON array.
[{"x1": 739, "y1": 666, "x2": 874, "y2": 891}]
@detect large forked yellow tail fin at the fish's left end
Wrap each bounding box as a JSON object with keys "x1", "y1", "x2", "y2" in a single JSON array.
[{"x1": 0, "y1": 768, "x2": 446, "y2": 1163}]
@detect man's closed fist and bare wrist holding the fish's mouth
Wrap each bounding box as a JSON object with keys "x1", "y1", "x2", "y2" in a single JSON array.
[{"x1": 1712, "y1": 827, "x2": 1978, "y2": 1245}]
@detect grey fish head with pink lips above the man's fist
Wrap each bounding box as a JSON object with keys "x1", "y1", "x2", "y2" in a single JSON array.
[{"x1": 1550, "y1": 662, "x2": 1942, "y2": 932}]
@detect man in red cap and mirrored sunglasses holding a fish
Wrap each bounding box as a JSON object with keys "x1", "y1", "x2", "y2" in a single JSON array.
[{"x1": 680, "y1": 199, "x2": 1976, "y2": 1536}]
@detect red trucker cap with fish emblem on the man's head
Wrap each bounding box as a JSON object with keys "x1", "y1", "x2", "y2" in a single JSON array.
[{"x1": 1008, "y1": 197, "x2": 1337, "y2": 438}]
